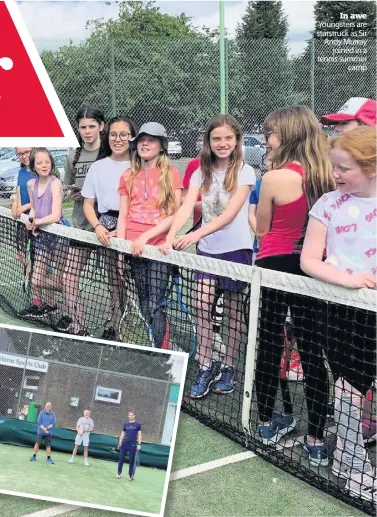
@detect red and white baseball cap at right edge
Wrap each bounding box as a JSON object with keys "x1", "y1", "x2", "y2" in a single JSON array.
[{"x1": 321, "y1": 97, "x2": 377, "y2": 126}]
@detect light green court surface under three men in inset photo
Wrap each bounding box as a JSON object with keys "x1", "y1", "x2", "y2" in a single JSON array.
[{"x1": 0, "y1": 445, "x2": 166, "y2": 513}]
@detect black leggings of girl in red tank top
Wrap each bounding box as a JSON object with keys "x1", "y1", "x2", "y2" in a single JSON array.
[{"x1": 255, "y1": 254, "x2": 328, "y2": 439}]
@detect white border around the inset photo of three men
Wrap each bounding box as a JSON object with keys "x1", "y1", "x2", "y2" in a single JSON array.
[{"x1": 0, "y1": 323, "x2": 188, "y2": 517}]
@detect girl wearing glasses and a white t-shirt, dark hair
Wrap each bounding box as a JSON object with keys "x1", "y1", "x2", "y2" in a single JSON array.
[{"x1": 81, "y1": 116, "x2": 136, "y2": 340}]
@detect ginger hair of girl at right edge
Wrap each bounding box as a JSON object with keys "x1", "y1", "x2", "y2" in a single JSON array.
[{"x1": 330, "y1": 126, "x2": 376, "y2": 178}]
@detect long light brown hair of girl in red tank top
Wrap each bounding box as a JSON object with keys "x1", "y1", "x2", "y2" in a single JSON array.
[{"x1": 264, "y1": 106, "x2": 335, "y2": 209}]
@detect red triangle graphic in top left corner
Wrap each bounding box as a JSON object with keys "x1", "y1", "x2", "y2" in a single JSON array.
[{"x1": 0, "y1": 1, "x2": 64, "y2": 138}]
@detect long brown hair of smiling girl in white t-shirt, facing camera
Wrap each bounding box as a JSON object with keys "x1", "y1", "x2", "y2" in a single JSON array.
[{"x1": 200, "y1": 115, "x2": 243, "y2": 193}]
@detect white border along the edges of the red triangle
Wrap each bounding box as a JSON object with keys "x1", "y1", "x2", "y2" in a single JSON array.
[{"x1": 0, "y1": 0, "x2": 79, "y2": 147}]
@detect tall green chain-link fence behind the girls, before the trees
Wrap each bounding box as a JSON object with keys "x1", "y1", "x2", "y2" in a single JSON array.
[{"x1": 37, "y1": 37, "x2": 376, "y2": 138}]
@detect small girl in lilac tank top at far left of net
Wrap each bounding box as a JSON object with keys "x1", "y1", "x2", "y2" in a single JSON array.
[{"x1": 20, "y1": 147, "x2": 68, "y2": 318}]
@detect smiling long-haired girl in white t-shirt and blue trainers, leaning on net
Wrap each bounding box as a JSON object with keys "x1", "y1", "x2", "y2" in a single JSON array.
[{"x1": 161, "y1": 115, "x2": 256, "y2": 399}]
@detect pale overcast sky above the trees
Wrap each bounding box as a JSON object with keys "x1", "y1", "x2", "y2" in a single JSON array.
[{"x1": 18, "y1": 0, "x2": 315, "y2": 54}]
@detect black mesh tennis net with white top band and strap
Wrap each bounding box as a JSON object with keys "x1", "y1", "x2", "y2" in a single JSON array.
[{"x1": 0, "y1": 209, "x2": 376, "y2": 514}]
